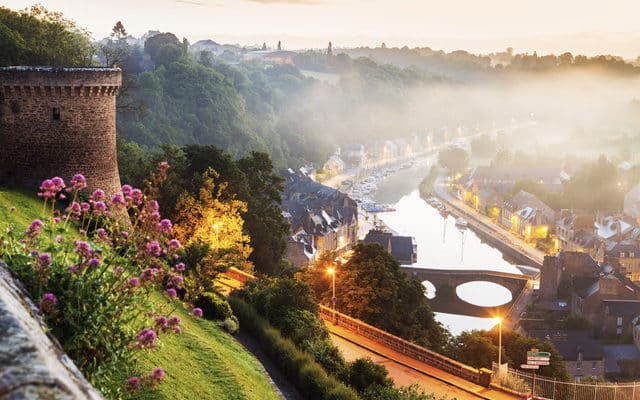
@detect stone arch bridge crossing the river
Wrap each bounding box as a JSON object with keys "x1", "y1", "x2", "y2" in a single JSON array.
[{"x1": 400, "y1": 266, "x2": 540, "y2": 317}]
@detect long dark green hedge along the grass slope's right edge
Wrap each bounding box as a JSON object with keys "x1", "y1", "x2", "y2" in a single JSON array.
[{"x1": 229, "y1": 296, "x2": 358, "y2": 400}]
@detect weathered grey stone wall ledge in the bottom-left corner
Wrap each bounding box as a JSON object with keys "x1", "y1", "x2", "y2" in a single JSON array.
[{"x1": 0, "y1": 260, "x2": 102, "y2": 400}]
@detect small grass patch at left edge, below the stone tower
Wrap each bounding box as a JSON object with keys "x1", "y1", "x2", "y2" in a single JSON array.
[{"x1": 0, "y1": 187, "x2": 42, "y2": 231}]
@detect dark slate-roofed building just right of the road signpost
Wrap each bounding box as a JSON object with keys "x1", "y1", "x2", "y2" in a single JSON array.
[{"x1": 528, "y1": 330, "x2": 605, "y2": 381}]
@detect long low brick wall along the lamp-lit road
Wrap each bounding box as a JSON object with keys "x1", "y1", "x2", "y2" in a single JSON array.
[{"x1": 319, "y1": 305, "x2": 491, "y2": 387}]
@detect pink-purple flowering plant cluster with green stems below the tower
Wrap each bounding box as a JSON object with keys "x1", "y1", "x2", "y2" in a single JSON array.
[{"x1": 0, "y1": 164, "x2": 184, "y2": 397}]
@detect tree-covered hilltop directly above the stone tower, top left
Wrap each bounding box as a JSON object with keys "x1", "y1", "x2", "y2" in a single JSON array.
[{"x1": 0, "y1": 5, "x2": 95, "y2": 67}]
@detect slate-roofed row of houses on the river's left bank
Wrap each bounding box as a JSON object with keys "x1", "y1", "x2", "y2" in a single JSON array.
[{"x1": 282, "y1": 169, "x2": 358, "y2": 266}]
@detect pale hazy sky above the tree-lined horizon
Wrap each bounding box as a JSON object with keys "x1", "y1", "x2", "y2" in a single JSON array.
[{"x1": 2, "y1": 0, "x2": 640, "y2": 58}]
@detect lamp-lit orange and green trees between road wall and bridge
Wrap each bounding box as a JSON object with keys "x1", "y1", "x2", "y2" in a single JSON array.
[{"x1": 302, "y1": 243, "x2": 448, "y2": 349}]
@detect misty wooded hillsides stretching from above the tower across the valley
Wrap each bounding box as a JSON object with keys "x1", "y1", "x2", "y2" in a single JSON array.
[{"x1": 0, "y1": 6, "x2": 640, "y2": 167}]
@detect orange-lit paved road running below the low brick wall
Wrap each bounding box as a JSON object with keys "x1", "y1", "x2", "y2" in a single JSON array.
[{"x1": 327, "y1": 324, "x2": 517, "y2": 400}]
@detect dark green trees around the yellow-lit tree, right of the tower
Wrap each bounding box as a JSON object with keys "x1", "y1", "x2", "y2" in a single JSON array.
[{"x1": 118, "y1": 141, "x2": 289, "y2": 275}]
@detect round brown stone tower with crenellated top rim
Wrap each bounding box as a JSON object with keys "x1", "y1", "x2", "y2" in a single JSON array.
[{"x1": 0, "y1": 67, "x2": 122, "y2": 195}]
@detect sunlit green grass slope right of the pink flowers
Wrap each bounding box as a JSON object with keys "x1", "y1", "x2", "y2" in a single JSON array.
[{"x1": 136, "y1": 299, "x2": 279, "y2": 400}]
